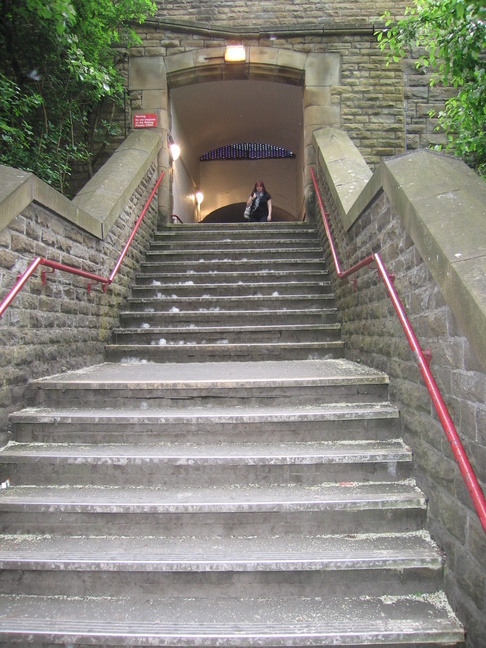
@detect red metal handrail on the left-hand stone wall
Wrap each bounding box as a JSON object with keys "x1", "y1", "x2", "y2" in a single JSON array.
[{"x1": 0, "y1": 172, "x2": 164, "y2": 317}]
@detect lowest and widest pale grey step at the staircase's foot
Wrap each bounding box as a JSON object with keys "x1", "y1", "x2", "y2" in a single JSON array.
[{"x1": 0, "y1": 591, "x2": 464, "y2": 648}]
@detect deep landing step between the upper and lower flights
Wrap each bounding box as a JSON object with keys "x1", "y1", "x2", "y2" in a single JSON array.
[{"x1": 27, "y1": 359, "x2": 389, "y2": 413}]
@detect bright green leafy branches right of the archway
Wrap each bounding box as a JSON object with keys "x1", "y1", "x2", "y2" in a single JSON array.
[{"x1": 377, "y1": 0, "x2": 486, "y2": 178}]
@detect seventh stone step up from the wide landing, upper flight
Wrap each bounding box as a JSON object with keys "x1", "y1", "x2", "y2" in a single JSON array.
[{"x1": 140, "y1": 257, "x2": 325, "y2": 275}]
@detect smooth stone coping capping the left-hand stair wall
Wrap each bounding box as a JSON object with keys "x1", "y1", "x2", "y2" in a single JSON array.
[{"x1": 0, "y1": 130, "x2": 161, "y2": 239}]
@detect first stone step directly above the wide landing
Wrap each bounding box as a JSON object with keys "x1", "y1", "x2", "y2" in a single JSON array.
[{"x1": 105, "y1": 339, "x2": 344, "y2": 363}]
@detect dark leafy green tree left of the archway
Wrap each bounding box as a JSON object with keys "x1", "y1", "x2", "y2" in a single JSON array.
[{"x1": 0, "y1": 0, "x2": 155, "y2": 193}]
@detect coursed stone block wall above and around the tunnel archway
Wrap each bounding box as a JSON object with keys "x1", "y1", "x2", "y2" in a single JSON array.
[{"x1": 69, "y1": 0, "x2": 453, "y2": 191}]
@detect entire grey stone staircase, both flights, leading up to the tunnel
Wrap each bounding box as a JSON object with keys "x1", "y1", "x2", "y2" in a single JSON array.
[{"x1": 0, "y1": 224, "x2": 464, "y2": 648}]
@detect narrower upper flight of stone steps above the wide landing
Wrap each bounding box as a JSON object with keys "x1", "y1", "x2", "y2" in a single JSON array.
[{"x1": 107, "y1": 223, "x2": 343, "y2": 362}]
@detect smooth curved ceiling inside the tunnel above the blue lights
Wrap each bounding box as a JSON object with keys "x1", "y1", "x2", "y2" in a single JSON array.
[{"x1": 171, "y1": 80, "x2": 303, "y2": 157}]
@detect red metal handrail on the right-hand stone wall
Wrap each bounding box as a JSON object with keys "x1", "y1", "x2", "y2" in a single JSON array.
[{"x1": 310, "y1": 169, "x2": 486, "y2": 533}]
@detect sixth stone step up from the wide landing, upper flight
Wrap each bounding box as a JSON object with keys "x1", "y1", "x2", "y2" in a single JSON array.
[{"x1": 135, "y1": 267, "x2": 329, "y2": 292}]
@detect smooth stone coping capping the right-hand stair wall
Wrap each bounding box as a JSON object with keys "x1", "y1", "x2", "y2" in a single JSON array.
[{"x1": 314, "y1": 128, "x2": 486, "y2": 370}]
